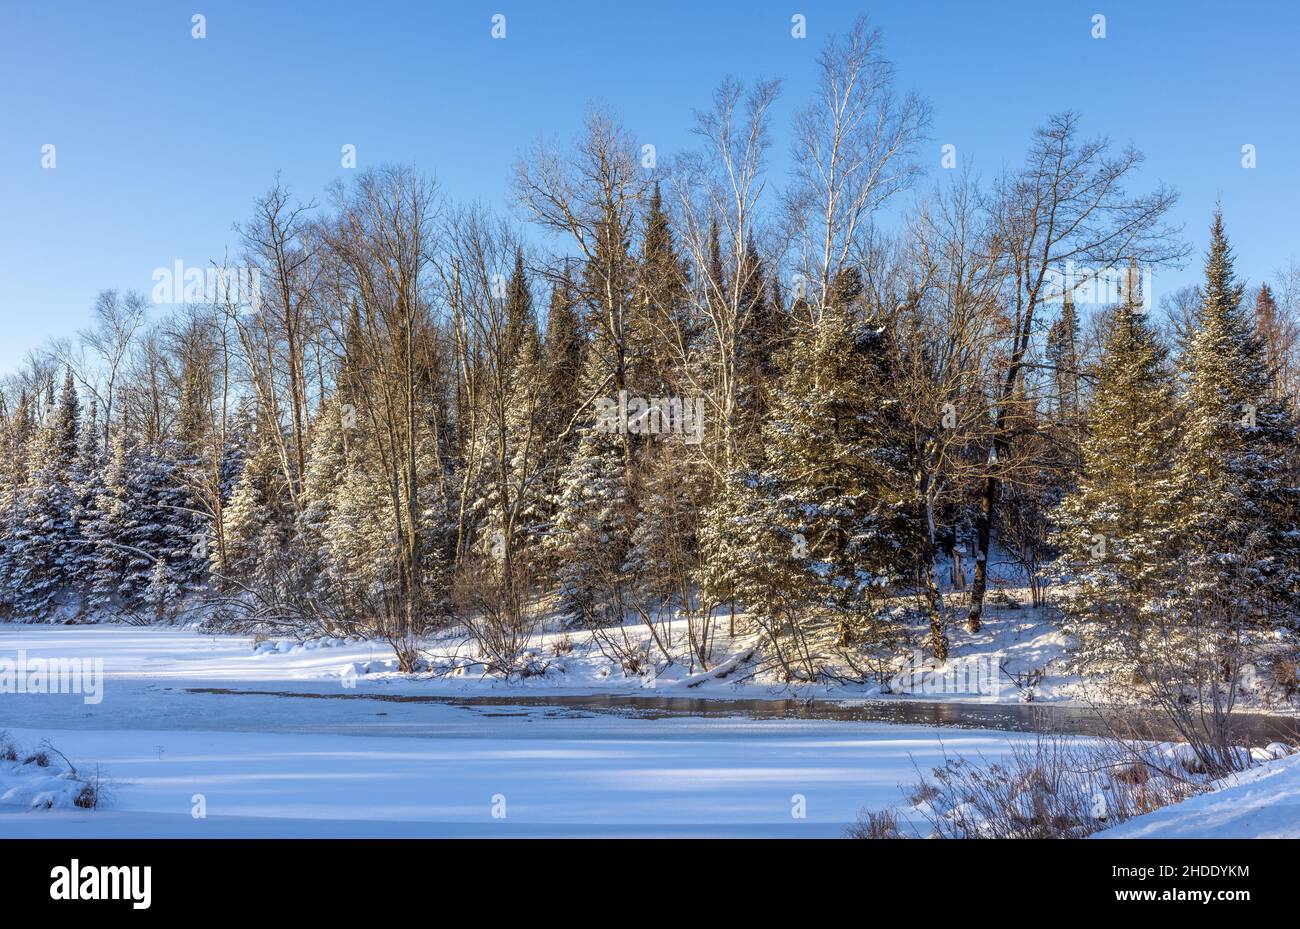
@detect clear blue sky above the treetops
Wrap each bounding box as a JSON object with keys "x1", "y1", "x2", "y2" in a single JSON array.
[{"x1": 0, "y1": 0, "x2": 1300, "y2": 370}]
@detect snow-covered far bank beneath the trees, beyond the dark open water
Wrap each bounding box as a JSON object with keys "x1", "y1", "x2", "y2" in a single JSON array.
[{"x1": 10, "y1": 561, "x2": 1300, "y2": 716}]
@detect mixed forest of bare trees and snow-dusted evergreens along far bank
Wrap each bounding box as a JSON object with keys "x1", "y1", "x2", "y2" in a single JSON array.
[{"x1": 0, "y1": 23, "x2": 1300, "y2": 696}]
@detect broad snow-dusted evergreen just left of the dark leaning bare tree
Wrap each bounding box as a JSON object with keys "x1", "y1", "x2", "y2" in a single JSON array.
[{"x1": 722, "y1": 307, "x2": 918, "y2": 646}]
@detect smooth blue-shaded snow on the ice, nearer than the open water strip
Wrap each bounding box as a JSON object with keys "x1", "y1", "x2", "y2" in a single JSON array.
[{"x1": 0, "y1": 717, "x2": 1034, "y2": 837}]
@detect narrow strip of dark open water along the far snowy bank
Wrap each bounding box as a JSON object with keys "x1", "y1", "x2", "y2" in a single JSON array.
[{"x1": 187, "y1": 687, "x2": 1300, "y2": 744}]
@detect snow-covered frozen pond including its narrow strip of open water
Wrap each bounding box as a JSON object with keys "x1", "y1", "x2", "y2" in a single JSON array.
[{"x1": 0, "y1": 626, "x2": 1294, "y2": 837}]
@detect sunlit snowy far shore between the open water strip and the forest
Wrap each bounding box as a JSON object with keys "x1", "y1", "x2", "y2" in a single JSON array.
[{"x1": 0, "y1": 607, "x2": 1075, "y2": 703}]
